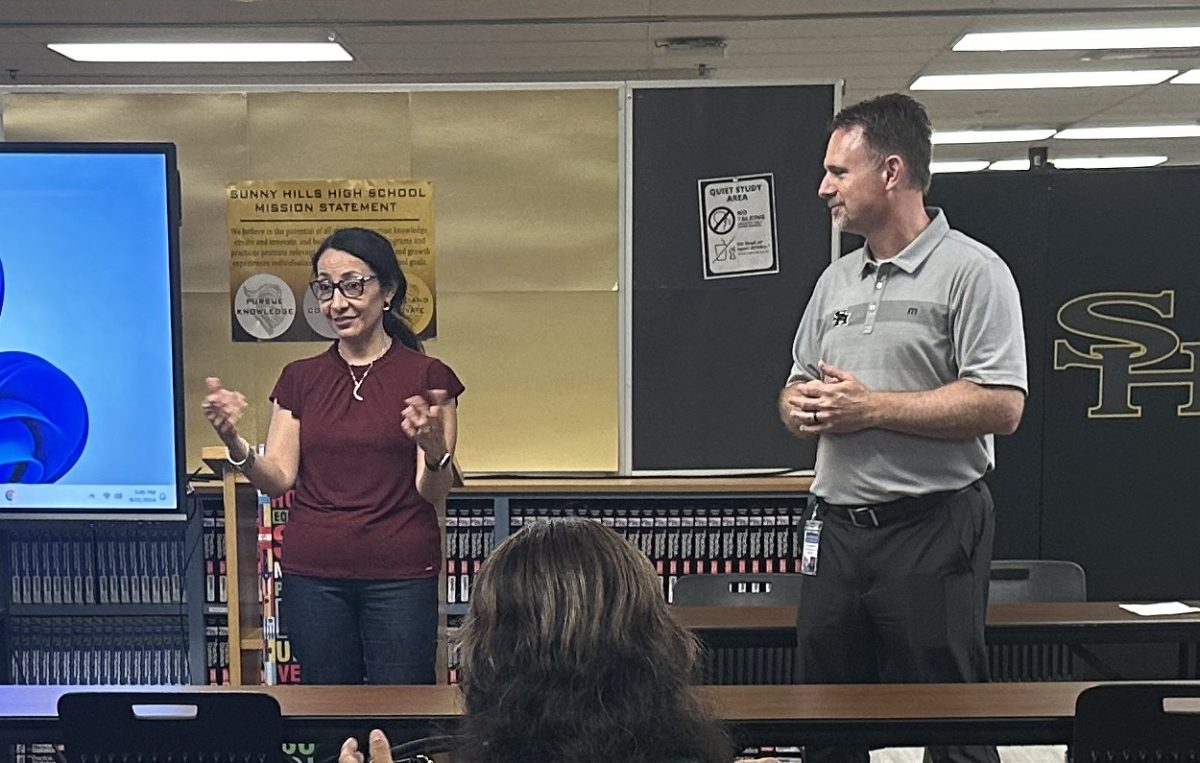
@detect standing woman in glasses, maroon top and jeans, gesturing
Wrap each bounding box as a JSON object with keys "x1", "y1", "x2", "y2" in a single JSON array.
[{"x1": 204, "y1": 228, "x2": 463, "y2": 684}]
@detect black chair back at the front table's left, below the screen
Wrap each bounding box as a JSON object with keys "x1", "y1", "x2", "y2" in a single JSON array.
[{"x1": 59, "y1": 691, "x2": 283, "y2": 763}]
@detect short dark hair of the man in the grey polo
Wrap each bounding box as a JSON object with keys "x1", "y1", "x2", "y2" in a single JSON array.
[{"x1": 830, "y1": 92, "x2": 932, "y2": 192}]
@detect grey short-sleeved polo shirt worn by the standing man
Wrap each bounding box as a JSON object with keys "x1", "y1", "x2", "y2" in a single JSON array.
[{"x1": 787, "y1": 208, "x2": 1028, "y2": 505}]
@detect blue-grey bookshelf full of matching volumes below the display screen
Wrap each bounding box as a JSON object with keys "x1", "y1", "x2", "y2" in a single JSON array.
[{"x1": 0, "y1": 485, "x2": 205, "y2": 685}]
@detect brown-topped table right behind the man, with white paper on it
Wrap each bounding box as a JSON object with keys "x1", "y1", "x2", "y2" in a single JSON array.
[{"x1": 672, "y1": 601, "x2": 1200, "y2": 678}]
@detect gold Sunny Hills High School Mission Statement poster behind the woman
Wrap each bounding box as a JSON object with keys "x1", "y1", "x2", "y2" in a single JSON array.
[{"x1": 226, "y1": 179, "x2": 437, "y2": 342}]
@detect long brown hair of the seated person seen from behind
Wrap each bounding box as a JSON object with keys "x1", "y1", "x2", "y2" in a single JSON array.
[{"x1": 458, "y1": 518, "x2": 732, "y2": 763}]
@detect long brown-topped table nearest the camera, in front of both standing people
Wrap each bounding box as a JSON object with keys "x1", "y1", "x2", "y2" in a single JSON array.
[{"x1": 0, "y1": 683, "x2": 1108, "y2": 746}]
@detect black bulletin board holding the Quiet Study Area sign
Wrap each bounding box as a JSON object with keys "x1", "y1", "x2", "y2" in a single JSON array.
[{"x1": 630, "y1": 84, "x2": 834, "y2": 471}]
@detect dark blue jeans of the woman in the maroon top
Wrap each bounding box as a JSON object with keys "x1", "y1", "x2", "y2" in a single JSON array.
[{"x1": 281, "y1": 573, "x2": 438, "y2": 684}]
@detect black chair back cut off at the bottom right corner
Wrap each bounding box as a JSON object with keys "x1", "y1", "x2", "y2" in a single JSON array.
[{"x1": 1072, "y1": 684, "x2": 1200, "y2": 763}]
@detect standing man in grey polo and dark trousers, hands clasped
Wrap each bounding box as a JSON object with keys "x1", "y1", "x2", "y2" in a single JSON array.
[{"x1": 779, "y1": 94, "x2": 1028, "y2": 761}]
